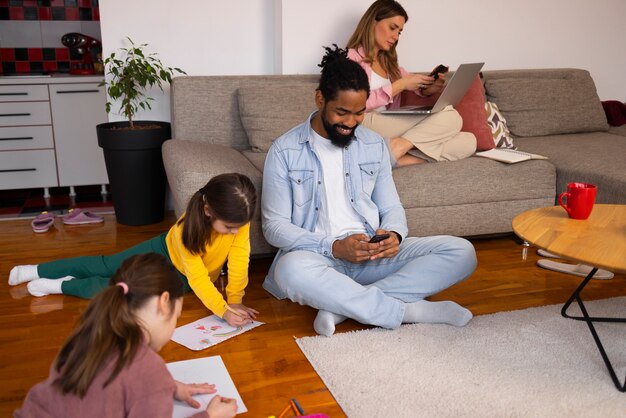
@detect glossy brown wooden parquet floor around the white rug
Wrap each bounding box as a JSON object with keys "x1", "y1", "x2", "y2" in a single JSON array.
[{"x1": 0, "y1": 213, "x2": 626, "y2": 418}]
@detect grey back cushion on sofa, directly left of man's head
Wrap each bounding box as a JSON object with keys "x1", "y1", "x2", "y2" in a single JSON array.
[{"x1": 237, "y1": 82, "x2": 317, "y2": 152}]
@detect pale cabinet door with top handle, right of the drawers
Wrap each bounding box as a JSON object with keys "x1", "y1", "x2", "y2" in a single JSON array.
[{"x1": 49, "y1": 83, "x2": 109, "y2": 186}]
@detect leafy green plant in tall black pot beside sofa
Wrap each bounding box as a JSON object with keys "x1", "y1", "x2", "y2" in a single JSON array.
[{"x1": 96, "y1": 38, "x2": 186, "y2": 225}]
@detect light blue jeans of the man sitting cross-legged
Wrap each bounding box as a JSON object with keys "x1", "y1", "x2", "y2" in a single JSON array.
[{"x1": 275, "y1": 235, "x2": 476, "y2": 328}]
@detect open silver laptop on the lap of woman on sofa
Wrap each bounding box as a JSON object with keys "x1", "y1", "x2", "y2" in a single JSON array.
[{"x1": 380, "y1": 62, "x2": 485, "y2": 115}]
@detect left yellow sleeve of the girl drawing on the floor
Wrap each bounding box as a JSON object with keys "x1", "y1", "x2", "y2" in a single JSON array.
[{"x1": 167, "y1": 222, "x2": 226, "y2": 318}]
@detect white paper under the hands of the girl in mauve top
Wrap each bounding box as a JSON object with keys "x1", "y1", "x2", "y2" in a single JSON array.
[{"x1": 167, "y1": 356, "x2": 248, "y2": 418}]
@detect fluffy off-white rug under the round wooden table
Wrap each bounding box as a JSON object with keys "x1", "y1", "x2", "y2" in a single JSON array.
[{"x1": 297, "y1": 297, "x2": 626, "y2": 418}]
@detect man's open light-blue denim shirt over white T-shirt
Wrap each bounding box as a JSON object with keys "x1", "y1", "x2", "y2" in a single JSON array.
[{"x1": 261, "y1": 112, "x2": 408, "y2": 299}]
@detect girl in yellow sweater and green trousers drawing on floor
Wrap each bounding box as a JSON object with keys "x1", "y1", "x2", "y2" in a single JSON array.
[{"x1": 9, "y1": 173, "x2": 258, "y2": 326}]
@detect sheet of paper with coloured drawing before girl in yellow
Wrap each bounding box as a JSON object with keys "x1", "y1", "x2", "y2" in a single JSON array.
[{"x1": 172, "y1": 315, "x2": 264, "y2": 351}]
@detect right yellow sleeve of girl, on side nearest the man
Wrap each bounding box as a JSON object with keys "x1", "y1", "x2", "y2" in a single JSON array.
[{"x1": 226, "y1": 223, "x2": 250, "y2": 303}]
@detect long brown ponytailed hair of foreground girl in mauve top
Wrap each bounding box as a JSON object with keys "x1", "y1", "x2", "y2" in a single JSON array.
[{"x1": 53, "y1": 253, "x2": 183, "y2": 398}]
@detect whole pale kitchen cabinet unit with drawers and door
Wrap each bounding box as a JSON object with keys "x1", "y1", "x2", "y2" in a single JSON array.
[{"x1": 0, "y1": 75, "x2": 109, "y2": 195}]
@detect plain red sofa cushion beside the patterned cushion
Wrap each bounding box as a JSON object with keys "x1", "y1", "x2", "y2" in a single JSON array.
[{"x1": 455, "y1": 75, "x2": 494, "y2": 151}]
